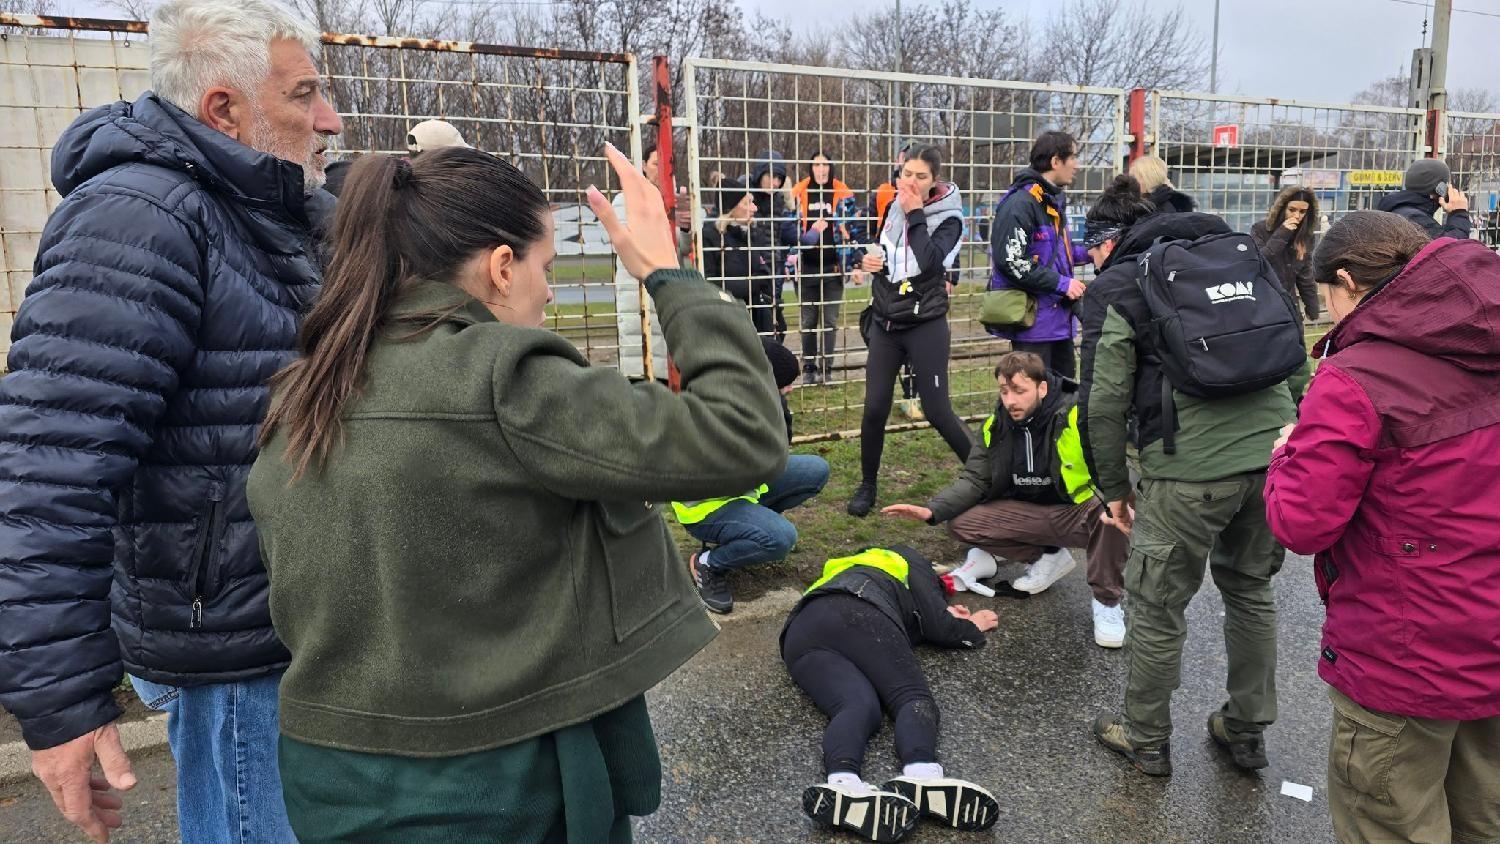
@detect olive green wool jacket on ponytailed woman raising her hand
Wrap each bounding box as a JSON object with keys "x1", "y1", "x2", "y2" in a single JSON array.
[{"x1": 248, "y1": 270, "x2": 786, "y2": 756}]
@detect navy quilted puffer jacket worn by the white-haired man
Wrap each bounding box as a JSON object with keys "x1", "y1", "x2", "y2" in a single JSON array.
[{"x1": 0, "y1": 93, "x2": 320, "y2": 748}]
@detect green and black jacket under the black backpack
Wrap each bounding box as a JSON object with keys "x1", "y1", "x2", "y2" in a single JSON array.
[{"x1": 1079, "y1": 213, "x2": 1307, "y2": 501}]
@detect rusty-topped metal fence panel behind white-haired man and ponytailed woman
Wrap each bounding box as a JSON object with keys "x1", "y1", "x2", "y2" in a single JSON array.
[{"x1": 0, "y1": 16, "x2": 641, "y2": 364}]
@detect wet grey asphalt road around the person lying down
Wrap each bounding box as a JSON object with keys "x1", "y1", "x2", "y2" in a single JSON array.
[{"x1": 0, "y1": 556, "x2": 1332, "y2": 844}]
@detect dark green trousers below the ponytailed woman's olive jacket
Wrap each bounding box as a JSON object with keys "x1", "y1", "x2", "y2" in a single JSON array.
[{"x1": 279, "y1": 697, "x2": 662, "y2": 844}]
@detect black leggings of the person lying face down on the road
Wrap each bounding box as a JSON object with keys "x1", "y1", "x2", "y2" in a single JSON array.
[{"x1": 782, "y1": 595, "x2": 938, "y2": 774}]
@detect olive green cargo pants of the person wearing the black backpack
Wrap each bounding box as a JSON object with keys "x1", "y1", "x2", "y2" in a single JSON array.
[{"x1": 1124, "y1": 472, "x2": 1286, "y2": 747}]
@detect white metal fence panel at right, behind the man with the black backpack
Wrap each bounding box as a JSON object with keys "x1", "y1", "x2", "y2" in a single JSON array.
[{"x1": 1151, "y1": 91, "x2": 1427, "y2": 231}]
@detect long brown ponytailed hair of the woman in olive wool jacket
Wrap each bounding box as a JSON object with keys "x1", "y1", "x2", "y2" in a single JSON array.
[{"x1": 260, "y1": 148, "x2": 548, "y2": 481}]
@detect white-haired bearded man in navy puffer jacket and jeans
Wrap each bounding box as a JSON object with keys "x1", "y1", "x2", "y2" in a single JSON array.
[{"x1": 0, "y1": 0, "x2": 341, "y2": 844}]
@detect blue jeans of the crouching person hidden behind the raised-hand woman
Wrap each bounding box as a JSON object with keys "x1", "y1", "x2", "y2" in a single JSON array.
[{"x1": 687, "y1": 454, "x2": 828, "y2": 568}]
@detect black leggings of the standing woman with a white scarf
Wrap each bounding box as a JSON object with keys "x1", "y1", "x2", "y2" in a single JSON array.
[{"x1": 860, "y1": 319, "x2": 974, "y2": 484}]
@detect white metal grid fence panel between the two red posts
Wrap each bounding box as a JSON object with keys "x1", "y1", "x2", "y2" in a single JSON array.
[{"x1": 684, "y1": 58, "x2": 1125, "y2": 439}]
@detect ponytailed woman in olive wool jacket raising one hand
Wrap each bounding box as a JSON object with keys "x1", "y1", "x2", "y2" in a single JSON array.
[{"x1": 249, "y1": 147, "x2": 786, "y2": 844}]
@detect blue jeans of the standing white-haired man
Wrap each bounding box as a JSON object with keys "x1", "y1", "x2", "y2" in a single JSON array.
[{"x1": 131, "y1": 673, "x2": 297, "y2": 844}]
